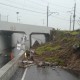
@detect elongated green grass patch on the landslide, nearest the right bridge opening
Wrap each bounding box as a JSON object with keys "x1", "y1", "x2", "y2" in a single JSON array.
[{"x1": 36, "y1": 44, "x2": 61, "y2": 55}]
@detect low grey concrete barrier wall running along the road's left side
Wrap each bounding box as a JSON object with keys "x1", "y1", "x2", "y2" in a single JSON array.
[{"x1": 0, "y1": 51, "x2": 24, "y2": 80}]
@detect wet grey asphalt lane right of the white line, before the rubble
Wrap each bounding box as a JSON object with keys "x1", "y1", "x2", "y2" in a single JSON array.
[{"x1": 24, "y1": 66, "x2": 80, "y2": 80}]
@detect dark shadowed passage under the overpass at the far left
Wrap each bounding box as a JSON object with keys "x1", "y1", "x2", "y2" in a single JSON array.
[{"x1": 0, "y1": 30, "x2": 25, "y2": 67}]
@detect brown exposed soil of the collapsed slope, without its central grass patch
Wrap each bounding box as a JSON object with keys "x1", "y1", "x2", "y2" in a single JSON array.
[{"x1": 34, "y1": 31, "x2": 80, "y2": 70}]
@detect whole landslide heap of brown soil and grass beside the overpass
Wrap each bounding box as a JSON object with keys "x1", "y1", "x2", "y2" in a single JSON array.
[{"x1": 35, "y1": 30, "x2": 80, "y2": 70}]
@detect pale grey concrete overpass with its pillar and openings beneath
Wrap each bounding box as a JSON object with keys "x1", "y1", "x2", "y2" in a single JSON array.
[{"x1": 0, "y1": 22, "x2": 52, "y2": 53}]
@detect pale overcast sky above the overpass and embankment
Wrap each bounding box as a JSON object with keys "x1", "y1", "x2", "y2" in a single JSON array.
[{"x1": 0, "y1": 0, "x2": 80, "y2": 30}]
